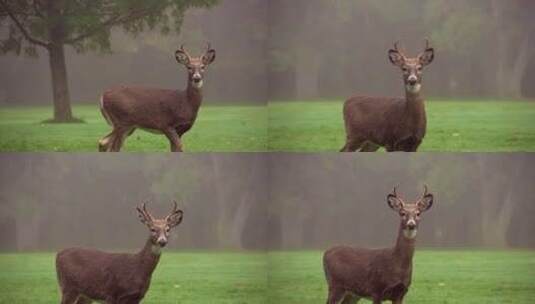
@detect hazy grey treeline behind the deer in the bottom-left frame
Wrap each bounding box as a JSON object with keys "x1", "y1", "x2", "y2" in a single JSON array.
[{"x1": 0, "y1": 154, "x2": 268, "y2": 251}]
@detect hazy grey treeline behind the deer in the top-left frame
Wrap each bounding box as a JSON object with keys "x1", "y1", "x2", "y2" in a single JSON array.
[{"x1": 0, "y1": 0, "x2": 268, "y2": 105}]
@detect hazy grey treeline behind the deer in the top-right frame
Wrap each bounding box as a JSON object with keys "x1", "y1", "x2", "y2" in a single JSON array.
[{"x1": 269, "y1": 0, "x2": 535, "y2": 99}]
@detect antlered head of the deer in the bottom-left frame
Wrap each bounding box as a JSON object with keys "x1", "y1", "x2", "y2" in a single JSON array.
[{"x1": 136, "y1": 201, "x2": 184, "y2": 247}]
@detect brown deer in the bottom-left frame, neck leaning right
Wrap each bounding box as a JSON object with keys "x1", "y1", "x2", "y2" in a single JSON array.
[{"x1": 56, "y1": 202, "x2": 183, "y2": 304}]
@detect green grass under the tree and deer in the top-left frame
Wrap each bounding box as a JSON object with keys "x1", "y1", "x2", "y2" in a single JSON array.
[{"x1": 0, "y1": 105, "x2": 267, "y2": 152}]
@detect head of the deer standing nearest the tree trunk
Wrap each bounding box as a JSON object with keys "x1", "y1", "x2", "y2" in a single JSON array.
[{"x1": 175, "y1": 43, "x2": 215, "y2": 89}]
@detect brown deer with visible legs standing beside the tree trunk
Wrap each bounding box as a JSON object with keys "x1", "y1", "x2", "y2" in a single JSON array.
[{"x1": 98, "y1": 44, "x2": 215, "y2": 152}]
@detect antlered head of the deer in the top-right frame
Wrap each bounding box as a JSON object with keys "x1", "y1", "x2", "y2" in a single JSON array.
[{"x1": 388, "y1": 39, "x2": 435, "y2": 94}]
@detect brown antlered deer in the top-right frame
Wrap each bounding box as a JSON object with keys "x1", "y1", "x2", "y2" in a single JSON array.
[{"x1": 340, "y1": 39, "x2": 435, "y2": 152}]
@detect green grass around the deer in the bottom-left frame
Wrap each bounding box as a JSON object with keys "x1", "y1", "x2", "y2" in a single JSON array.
[{"x1": 0, "y1": 252, "x2": 266, "y2": 304}]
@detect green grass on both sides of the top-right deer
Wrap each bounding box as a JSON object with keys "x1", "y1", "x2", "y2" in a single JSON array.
[{"x1": 268, "y1": 100, "x2": 535, "y2": 152}]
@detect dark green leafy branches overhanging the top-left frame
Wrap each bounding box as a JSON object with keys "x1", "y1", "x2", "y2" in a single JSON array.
[{"x1": 0, "y1": 0, "x2": 218, "y2": 56}]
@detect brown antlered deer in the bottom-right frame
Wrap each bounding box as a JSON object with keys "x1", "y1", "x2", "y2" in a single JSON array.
[{"x1": 323, "y1": 187, "x2": 433, "y2": 304}]
